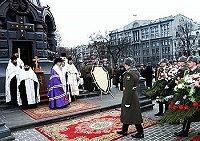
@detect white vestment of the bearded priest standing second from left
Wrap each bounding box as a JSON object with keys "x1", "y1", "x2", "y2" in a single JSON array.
[{"x1": 17, "y1": 68, "x2": 40, "y2": 106}]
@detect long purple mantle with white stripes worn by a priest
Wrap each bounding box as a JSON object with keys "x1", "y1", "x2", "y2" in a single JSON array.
[{"x1": 48, "y1": 69, "x2": 70, "y2": 109}]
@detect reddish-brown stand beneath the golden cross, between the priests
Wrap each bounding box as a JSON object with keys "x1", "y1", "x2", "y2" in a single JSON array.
[{"x1": 35, "y1": 71, "x2": 48, "y2": 104}]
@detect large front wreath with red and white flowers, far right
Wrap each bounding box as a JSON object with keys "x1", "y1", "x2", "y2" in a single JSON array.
[{"x1": 160, "y1": 74, "x2": 200, "y2": 124}]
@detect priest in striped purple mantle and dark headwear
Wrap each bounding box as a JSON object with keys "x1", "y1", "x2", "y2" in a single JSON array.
[{"x1": 48, "y1": 58, "x2": 70, "y2": 109}]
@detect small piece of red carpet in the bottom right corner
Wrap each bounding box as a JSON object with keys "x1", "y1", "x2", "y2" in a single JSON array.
[{"x1": 175, "y1": 130, "x2": 200, "y2": 141}]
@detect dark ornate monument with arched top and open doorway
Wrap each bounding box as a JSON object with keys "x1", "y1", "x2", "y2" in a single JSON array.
[{"x1": 0, "y1": 0, "x2": 56, "y2": 138}]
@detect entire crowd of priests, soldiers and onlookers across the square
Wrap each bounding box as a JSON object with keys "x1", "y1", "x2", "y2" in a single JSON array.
[{"x1": 5, "y1": 54, "x2": 200, "y2": 138}]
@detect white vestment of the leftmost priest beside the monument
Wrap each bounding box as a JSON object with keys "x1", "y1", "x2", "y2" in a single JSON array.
[{"x1": 5, "y1": 62, "x2": 21, "y2": 102}]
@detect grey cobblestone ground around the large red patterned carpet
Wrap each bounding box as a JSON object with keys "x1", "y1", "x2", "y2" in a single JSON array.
[{"x1": 12, "y1": 104, "x2": 200, "y2": 141}]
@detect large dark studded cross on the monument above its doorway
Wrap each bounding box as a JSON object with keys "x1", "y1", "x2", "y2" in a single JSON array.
[{"x1": 7, "y1": 15, "x2": 35, "y2": 38}]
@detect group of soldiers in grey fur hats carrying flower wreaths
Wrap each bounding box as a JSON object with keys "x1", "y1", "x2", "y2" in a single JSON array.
[{"x1": 144, "y1": 56, "x2": 200, "y2": 137}]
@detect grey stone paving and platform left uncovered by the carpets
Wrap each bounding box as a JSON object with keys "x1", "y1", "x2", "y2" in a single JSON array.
[{"x1": 0, "y1": 87, "x2": 200, "y2": 141}]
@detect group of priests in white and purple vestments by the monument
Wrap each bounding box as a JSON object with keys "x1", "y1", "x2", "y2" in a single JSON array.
[{"x1": 5, "y1": 53, "x2": 80, "y2": 109}]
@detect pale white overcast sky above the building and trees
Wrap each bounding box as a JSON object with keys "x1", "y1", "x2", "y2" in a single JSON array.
[{"x1": 40, "y1": 0, "x2": 200, "y2": 47}]
